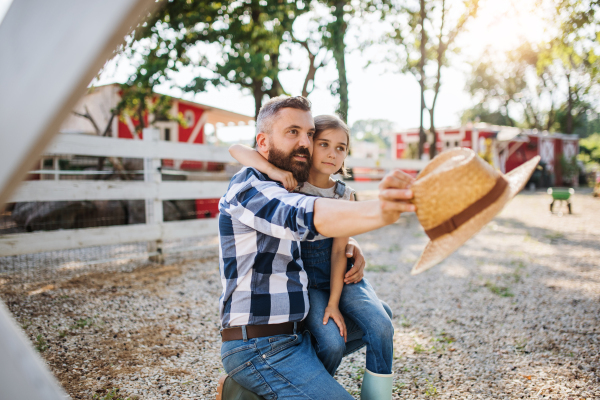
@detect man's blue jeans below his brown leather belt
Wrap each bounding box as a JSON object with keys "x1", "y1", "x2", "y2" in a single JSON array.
[{"x1": 221, "y1": 331, "x2": 353, "y2": 400}]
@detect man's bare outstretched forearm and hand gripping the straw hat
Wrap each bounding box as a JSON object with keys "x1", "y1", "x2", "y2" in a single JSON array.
[{"x1": 313, "y1": 170, "x2": 416, "y2": 237}]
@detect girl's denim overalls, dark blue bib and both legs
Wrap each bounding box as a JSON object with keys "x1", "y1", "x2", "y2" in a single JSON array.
[{"x1": 300, "y1": 181, "x2": 394, "y2": 376}]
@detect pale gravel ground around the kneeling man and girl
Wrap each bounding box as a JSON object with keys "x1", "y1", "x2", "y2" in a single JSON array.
[{"x1": 0, "y1": 191, "x2": 600, "y2": 399}]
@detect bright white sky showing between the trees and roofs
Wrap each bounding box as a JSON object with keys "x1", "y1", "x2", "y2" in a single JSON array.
[{"x1": 0, "y1": 0, "x2": 544, "y2": 139}]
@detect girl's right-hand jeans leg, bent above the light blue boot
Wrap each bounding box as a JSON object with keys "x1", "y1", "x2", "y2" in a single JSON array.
[{"x1": 338, "y1": 279, "x2": 394, "y2": 374}]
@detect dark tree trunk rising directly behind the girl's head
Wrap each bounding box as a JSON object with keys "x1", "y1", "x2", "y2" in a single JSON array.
[{"x1": 330, "y1": 1, "x2": 348, "y2": 123}]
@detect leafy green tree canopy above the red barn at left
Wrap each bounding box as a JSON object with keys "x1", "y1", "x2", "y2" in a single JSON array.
[{"x1": 126, "y1": 0, "x2": 307, "y2": 119}]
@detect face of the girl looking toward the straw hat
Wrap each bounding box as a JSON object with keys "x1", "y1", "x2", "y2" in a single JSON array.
[{"x1": 312, "y1": 129, "x2": 348, "y2": 175}]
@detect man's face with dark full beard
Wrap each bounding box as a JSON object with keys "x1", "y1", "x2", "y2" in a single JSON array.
[{"x1": 267, "y1": 108, "x2": 315, "y2": 182}]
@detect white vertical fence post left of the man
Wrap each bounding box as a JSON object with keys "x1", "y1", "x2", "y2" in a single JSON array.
[{"x1": 143, "y1": 128, "x2": 164, "y2": 263}]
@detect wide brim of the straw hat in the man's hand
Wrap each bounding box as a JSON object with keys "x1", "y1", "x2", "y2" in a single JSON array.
[{"x1": 410, "y1": 156, "x2": 540, "y2": 275}]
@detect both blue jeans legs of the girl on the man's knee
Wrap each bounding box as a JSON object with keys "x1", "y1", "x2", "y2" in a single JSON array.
[{"x1": 304, "y1": 279, "x2": 394, "y2": 376}]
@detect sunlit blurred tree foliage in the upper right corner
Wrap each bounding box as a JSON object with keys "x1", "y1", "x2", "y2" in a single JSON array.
[{"x1": 463, "y1": 0, "x2": 600, "y2": 136}]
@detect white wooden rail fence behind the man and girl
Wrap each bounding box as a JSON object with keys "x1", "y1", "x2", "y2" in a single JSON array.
[{"x1": 0, "y1": 129, "x2": 424, "y2": 256}]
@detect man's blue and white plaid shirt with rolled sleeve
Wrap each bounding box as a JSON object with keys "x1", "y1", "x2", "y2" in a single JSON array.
[{"x1": 219, "y1": 168, "x2": 323, "y2": 328}]
